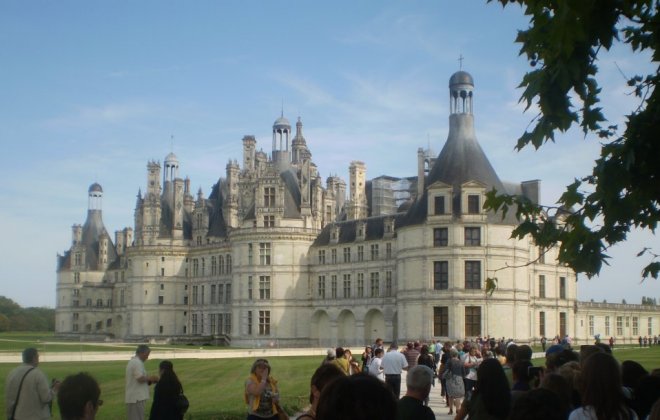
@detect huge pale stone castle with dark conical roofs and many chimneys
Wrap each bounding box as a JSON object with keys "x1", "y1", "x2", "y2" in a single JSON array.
[{"x1": 56, "y1": 71, "x2": 658, "y2": 347}]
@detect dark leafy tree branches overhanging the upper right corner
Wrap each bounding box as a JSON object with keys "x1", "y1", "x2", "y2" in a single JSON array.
[{"x1": 485, "y1": 0, "x2": 660, "y2": 279}]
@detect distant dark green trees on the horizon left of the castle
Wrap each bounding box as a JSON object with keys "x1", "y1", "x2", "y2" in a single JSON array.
[{"x1": 0, "y1": 296, "x2": 55, "y2": 332}]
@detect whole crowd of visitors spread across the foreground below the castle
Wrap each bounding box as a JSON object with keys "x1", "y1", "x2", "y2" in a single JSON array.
[{"x1": 5, "y1": 337, "x2": 660, "y2": 420}]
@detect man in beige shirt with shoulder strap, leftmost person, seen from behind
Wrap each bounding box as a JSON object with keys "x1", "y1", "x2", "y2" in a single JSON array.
[{"x1": 5, "y1": 347, "x2": 60, "y2": 420}]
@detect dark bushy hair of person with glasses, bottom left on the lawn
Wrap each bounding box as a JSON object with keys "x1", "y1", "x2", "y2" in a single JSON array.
[{"x1": 57, "y1": 372, "x2": 102, "y2": 420}]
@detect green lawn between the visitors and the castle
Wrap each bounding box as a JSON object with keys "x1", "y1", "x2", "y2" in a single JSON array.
[{"x1": 0, "y1": 334, "x2": 660, "y2": 420}]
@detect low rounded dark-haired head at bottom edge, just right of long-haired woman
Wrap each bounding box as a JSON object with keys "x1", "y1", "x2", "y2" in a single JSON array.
[{"x1": 509, "y1": 388, "x2": 568, "y2": 420}]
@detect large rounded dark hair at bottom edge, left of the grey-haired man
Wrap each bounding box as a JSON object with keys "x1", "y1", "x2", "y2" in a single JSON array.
[{"x1": 316, "y1": 373, "x2": 397, "y2": 420}]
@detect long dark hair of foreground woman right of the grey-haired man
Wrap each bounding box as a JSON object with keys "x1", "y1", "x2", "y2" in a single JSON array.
[{"x1": 475, "y1": 359, "x2": 511, "y2": 419}]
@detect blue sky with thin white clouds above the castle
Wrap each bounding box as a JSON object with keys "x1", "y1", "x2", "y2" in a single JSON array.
[{"x1": 0, "y1": 0, "x2": 660, "y2": 307}]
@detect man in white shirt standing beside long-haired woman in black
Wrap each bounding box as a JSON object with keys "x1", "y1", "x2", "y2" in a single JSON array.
[{"x1": 124, "y1": 344, "x2": 158, "y2": 420}]
